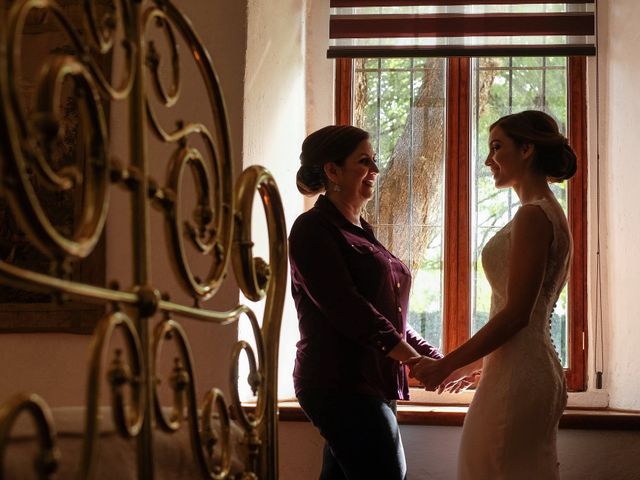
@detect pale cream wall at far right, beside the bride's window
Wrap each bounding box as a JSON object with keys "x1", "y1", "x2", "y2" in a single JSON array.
[{"x1": 591, "y1": 0, "x2": 640, "y2": 409}]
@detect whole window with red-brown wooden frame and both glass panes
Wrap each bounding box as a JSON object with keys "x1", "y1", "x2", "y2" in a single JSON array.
[{"x1": 336, "y1": 57, "x2": 586, "y2": 390}]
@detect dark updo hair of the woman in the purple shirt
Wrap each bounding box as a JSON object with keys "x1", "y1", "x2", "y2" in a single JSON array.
[{"x1": 296, "y1": 125, "x2": 369, "y2": 196}]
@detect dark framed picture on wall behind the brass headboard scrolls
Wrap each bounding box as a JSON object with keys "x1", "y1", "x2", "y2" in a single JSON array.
[{"x1": 0, "y1": 0, "x2": 112, "y2": 334}]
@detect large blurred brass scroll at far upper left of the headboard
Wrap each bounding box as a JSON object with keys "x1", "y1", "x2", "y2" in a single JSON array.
[{"x1": 3, "y1": 0, "x2": 108, "y2": 258}]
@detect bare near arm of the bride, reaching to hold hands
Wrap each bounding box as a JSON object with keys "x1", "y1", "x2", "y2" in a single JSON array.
[{"x1": 412, "y1": 205, "x2": 553, "y2": 389}]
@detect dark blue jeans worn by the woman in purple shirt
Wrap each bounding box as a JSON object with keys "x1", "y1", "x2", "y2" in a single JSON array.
[{"x1": 298, "y1": 389, "x2": 407, "y2": 480}]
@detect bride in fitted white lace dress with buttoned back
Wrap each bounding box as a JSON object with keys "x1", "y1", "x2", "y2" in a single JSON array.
[{"x1": 408, "y1": 111, "x2": 576, "y2": 480}]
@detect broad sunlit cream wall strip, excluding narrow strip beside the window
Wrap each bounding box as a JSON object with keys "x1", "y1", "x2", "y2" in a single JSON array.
[{"x1": 240, "y1": 0, "x2": 305, "y2": 397}]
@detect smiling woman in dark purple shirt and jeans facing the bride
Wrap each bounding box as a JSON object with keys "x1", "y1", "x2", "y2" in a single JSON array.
[{"x1": 289, "y1": 126, "x2": 442, "y2": 480}]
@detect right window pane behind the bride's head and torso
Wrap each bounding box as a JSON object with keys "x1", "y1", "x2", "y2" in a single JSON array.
[{"x1": 470, "y1": 57, "x2": 568, "y2": 367}]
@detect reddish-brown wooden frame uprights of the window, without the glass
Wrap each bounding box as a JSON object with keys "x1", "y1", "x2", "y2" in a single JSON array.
[{"x1": 335, "y1": 56, "x2": 588, "y2": 391}]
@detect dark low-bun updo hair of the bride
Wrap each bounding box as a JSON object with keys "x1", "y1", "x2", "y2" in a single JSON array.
[{"x1": 489, "y1": 110, "x2": 577, "y2": 181}]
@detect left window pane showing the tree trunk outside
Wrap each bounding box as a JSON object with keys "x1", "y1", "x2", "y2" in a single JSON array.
[{"x1": 353, "y1": 58, "x2": 446, "y2": 347}]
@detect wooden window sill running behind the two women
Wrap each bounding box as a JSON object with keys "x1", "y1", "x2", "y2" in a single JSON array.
[{"x1": 278, "y1": 392, "x2": 640, "y2": 430}]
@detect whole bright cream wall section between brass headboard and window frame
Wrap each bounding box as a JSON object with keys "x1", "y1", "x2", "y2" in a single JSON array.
[{"x1": 240, "y1": 0, "x2": 334, "y2": 398}]
